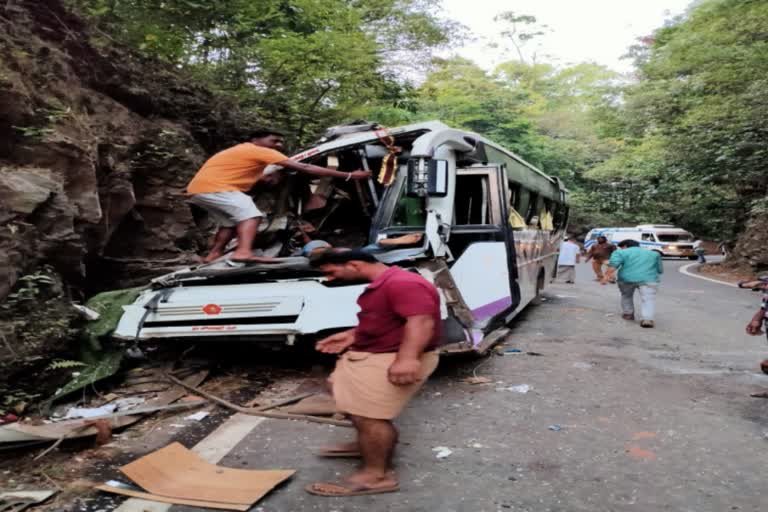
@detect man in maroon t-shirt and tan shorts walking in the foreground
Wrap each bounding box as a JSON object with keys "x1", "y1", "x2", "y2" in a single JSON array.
[{"x1": 306, "y1": 250, "x2": 441, "y2": 496}]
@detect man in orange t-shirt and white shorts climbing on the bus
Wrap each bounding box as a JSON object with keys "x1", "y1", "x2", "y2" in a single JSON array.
[{"x1": 187, "y1": 129, "x2": 371, "y2": 263}]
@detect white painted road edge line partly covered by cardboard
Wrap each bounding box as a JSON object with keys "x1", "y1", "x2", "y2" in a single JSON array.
[{"x1": 115, "y1": 413, "x2": 267, "y2": 512}]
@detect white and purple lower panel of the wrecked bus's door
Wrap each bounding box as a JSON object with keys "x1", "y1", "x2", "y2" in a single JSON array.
[{"x1": 451, "y1": 242, "x2": 517, "y2": 327}]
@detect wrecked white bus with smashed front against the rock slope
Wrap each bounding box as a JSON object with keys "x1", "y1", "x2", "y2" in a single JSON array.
[{"x1": 115, "y1": 121, "x2": 568, "y2": 353}]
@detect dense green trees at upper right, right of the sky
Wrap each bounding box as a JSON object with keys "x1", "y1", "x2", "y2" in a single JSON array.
[{"x1": 588, "y1": 0, "x2": 768, "y2": 239}]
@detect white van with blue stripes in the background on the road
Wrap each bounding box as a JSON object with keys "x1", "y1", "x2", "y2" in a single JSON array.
[{"x1": 584, "y1": 224, "x2": 696, "y2": 260}]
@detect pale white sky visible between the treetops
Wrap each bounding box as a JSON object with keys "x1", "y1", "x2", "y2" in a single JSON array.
[{"x1": 443, "y1": 0, "x2": 691, "y2": 72}]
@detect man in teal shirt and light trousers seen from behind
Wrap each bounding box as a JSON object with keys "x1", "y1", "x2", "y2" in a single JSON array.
[{"x1": 601, "y1": 240, "x2": 664, "y2": 328}]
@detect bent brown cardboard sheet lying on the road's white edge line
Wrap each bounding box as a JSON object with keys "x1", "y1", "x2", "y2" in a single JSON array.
[{"x1": 120, "y1": 443, "x2": 295, "y2": 505}]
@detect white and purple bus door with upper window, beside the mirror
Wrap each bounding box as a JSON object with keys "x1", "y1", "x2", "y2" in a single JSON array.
[{"x1": 448, "y1": 165, "x2": 519, "y2": 328}]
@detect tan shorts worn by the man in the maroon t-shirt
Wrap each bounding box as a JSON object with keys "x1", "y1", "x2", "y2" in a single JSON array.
[{"x1": 330, "y1": 351, "x2": 439, "y2": 420}]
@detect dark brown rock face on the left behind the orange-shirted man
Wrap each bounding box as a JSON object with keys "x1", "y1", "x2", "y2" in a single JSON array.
[{"x1": 0, "y1": 0, "x2": 257, "y2": 300}]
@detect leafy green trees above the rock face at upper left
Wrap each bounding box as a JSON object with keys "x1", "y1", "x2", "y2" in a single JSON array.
[{"x1": 70, "y1": 0, "x2": 456, "y2": 144}]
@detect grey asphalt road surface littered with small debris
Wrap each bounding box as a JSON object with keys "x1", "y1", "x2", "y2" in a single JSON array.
[{"x1": 164, "y1": 260, "x2": 768, "y2": 512}]
